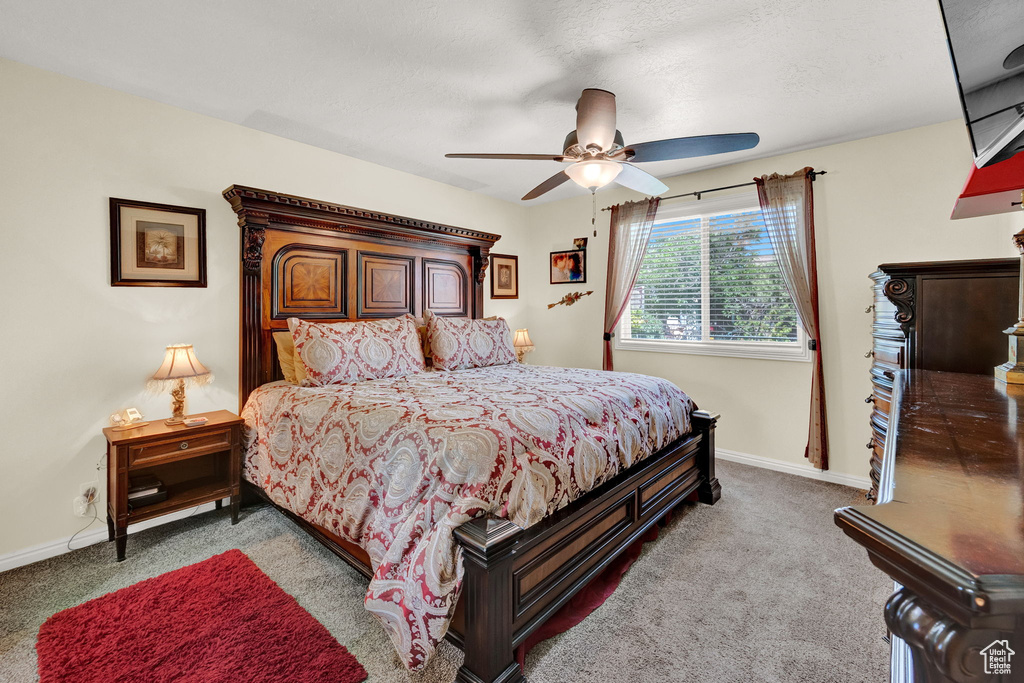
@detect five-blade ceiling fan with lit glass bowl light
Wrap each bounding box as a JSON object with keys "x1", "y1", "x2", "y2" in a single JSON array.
[{"x1": 444, "y1": 88, "x2": 761, "y2": 201}]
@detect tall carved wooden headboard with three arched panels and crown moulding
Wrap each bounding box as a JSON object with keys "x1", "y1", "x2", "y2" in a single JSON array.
[{"x1": 223, "y1": 185, "x2": 500, "y2": 409}]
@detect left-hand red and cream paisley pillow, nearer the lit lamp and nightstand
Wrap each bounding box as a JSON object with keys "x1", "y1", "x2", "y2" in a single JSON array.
[{"x1": 288, "y1": 315, "x2": 424, "y2": 386}]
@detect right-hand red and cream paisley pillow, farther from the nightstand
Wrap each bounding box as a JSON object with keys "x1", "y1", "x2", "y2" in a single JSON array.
[{"x1": 426, "y1": 311, "x2": 515, "y2": 370}]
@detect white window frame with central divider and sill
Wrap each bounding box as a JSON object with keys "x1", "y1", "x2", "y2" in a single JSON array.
[{"x1": 613, "y1": 193, "x2": 814, "y2": 362}]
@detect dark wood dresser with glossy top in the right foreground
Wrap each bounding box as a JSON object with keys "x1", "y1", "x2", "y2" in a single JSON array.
[{"x1": 835, "y1": 370, "x2": 1024, "y2": 683}]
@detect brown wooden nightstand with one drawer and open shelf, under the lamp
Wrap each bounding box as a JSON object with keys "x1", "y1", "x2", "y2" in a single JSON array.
[{"x1": 103, "y1": 411, "x2": 243, "y2": 562}]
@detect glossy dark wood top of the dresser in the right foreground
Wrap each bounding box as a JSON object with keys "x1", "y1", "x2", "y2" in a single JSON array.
[{"x1": 836, "y1": 370, "x2": 1024, "y2": 612}]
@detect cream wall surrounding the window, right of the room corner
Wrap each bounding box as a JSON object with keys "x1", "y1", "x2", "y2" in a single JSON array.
[{"x1": 523, "y1": 121, "x2": 1024, "y2": 477}]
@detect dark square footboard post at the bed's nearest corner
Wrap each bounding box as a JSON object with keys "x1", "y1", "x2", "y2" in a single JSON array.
[{"x1": 454, "y1": 516, "x2": 526, "y2": 683}]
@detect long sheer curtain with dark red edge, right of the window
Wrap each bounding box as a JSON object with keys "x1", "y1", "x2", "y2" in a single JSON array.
[{"x1": 754, "y1": 167, "x2": 828, "y2": 470}]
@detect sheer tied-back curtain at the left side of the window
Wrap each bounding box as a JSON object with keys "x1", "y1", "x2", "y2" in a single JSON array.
[{"x1": 604, "y1": 197, "x2": 660, "y2": 370}]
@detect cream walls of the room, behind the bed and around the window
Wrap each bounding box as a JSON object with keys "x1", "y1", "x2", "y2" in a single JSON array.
[{"x1": 6, "y1": 60, "x2": 1022, "y2": 557}]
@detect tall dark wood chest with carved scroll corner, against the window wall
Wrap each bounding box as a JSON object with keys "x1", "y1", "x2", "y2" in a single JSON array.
[{"x1": 865, "y1": 258, "x2": 1020, "y2": 500}]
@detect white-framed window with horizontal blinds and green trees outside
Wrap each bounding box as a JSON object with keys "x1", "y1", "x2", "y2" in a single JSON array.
[{"x1": 615, "y1": 194, "x2": 811, "y2": 360}]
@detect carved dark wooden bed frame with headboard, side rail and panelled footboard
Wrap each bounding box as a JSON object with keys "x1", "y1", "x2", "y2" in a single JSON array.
[{"x1": 223, "y1": 185, "x2": 721, "y2": 683}]
